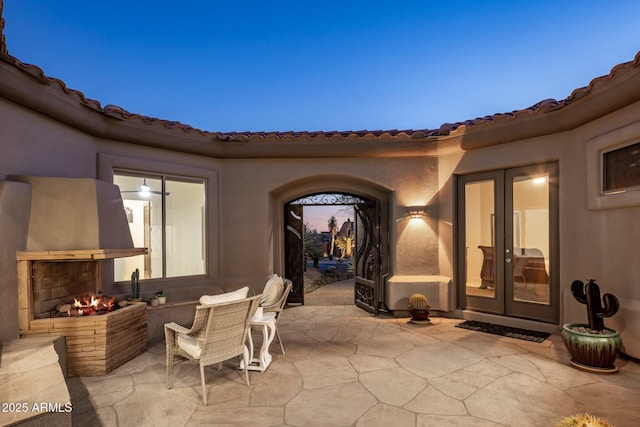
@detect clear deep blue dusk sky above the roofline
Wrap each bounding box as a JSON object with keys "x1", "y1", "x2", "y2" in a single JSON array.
[{"x1": 4, "y1": 0, "x2": 640, "y2": 131}]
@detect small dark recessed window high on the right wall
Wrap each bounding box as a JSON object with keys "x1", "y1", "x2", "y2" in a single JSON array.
[{"x1": 602, "y1": 142, "x2": 640, "y2": 193}]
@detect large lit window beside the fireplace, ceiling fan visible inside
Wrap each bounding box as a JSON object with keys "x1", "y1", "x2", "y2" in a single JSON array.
[{"x1": 113, "y1": 171, "x2": 206, "y2": 281}]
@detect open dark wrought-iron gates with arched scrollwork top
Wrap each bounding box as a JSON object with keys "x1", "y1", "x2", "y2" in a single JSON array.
[{"x1": 284, "y1": 192, "x2": 388, "y2": 314}]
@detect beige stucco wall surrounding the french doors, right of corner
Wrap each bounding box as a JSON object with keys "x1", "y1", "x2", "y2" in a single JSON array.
[{"x1": 439, "y1": 103, "x2": 640, "y2": 357}]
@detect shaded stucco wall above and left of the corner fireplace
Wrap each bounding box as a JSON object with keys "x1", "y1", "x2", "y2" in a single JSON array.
[{"x1": 0, "y1": 98, "x2": 96, "y2": 342}]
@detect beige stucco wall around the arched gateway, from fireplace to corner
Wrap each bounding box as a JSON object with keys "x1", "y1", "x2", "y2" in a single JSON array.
[{"x1": 0, "y1": 96, "x2": 439, "y2": 342}]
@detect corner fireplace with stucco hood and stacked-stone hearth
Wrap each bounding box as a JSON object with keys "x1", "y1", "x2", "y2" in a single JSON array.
[{"x1": 10, "y1": 176, "x2": 147, "y2": 376}]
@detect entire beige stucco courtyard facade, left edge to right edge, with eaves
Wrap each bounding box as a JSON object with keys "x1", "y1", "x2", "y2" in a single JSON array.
[{"x1": 0, "y1": 7, "x2": 640, "y2": 358}]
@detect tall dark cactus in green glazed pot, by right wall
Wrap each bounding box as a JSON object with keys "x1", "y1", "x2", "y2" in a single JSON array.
[{"x1": 562, "y1": 279, "x2": 622, "y2": 373}]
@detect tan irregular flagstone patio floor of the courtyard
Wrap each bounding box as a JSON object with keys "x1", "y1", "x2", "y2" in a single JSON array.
[{"x1": 67, "y1": 306, "x2": 640, "y2": 427}]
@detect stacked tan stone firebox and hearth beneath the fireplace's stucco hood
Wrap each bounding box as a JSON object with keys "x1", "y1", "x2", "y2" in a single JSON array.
[{"x1": 17, "y1": 249, "x2": 147, "y2": 376}]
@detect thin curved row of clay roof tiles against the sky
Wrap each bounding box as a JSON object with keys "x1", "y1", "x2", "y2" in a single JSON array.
[{"x1": 0, "y1": 47, "x2": 640, "y2": 142}]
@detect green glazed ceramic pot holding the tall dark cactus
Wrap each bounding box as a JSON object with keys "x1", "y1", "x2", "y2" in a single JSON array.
[{"x1": 562, "y1": 323, "x2": 622, "y2": 373}]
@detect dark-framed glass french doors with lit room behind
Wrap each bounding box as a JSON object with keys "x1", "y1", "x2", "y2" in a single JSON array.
[{"x1": 457, "y1": 163, "x2": 560, "y2": 323}]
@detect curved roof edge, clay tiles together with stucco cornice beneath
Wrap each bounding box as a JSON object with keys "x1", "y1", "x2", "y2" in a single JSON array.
[{"x1": 0, "y1": 10, "x2": 640, "y2": 157}]
